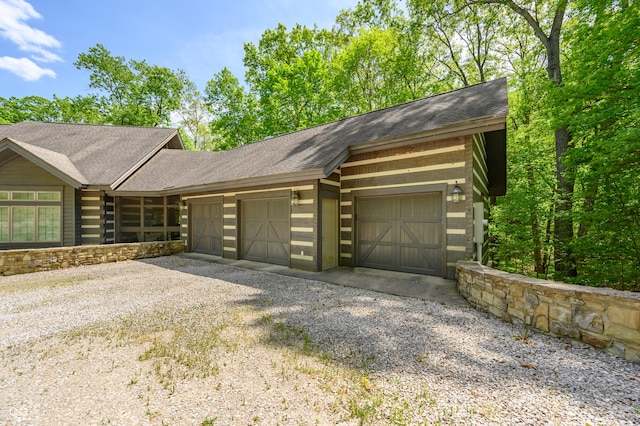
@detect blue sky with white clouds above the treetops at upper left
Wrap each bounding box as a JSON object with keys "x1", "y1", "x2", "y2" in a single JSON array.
[{"x1": 0, "y1": 0, "x2": 357, "y2": 98}]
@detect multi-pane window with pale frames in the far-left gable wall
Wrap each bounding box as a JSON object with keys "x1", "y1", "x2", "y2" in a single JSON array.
[{"x1": 0, "y1": 190, "x2": 62, "y2": 243}]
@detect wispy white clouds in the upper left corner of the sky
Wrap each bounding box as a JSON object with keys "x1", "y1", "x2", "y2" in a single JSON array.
[{"x1": 0, "y1": 0, "x2": 62, "y2": 80}]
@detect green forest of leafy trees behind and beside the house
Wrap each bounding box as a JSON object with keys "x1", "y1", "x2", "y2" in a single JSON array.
[{"x1": 0, "y1": 0, "x2": 640, "y2": 291}]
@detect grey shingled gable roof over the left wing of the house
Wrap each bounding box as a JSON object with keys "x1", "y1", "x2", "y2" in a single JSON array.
[{"x1": 0, "y1": 121, "x2": 184, "y2": 189}]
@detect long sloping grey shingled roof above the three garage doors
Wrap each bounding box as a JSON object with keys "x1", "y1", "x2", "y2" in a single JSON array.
[{"x1": 118, "y1": 78, "x2": 508, "y2": 193}]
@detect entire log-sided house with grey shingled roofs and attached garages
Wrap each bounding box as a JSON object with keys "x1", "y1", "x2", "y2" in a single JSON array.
[{"x1": 0, "y1": 79, "x2": 508, "y2": 278}]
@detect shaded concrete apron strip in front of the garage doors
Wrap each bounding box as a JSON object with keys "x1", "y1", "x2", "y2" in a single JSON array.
[{"x1": 174, "y1": 253, "x2": 469, "y2": 306}]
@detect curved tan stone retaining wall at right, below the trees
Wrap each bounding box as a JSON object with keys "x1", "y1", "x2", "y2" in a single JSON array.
[{"x1": 457, "y1": 262, "x2": 640, "y2": 363}]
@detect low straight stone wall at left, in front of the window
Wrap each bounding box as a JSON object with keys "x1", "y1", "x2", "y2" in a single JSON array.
[{"x1": 0, "y1": 241, "x2": 184, "y2": 275}]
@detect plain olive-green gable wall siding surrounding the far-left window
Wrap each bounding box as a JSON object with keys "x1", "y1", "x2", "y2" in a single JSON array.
[{"x1": 0, "y1": 157, "x2": 77, "y2": 248}]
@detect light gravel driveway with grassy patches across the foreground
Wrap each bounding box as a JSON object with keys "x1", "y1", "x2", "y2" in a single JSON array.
[{"x1": 0, "y1": 257, "x2": 640, "y2": 425}]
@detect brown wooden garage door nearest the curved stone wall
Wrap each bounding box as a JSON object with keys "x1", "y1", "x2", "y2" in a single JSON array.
[{"x1": 356, "y1": 193, "x2": 444, "y2": 276}]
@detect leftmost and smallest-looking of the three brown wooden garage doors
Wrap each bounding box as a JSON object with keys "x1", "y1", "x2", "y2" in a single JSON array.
[{"x1": 190, "y1": 203, "x2": 223, "y2": 256}]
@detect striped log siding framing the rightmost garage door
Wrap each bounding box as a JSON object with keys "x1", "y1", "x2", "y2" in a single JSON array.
[{"x1": 340, "y1": 136, "x2": 473, "y2": 278}]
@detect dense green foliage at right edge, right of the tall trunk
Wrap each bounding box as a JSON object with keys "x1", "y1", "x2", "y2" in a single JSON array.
[{"x1": 554, "y1": 0, "x2": 640, "y2": 290}]
